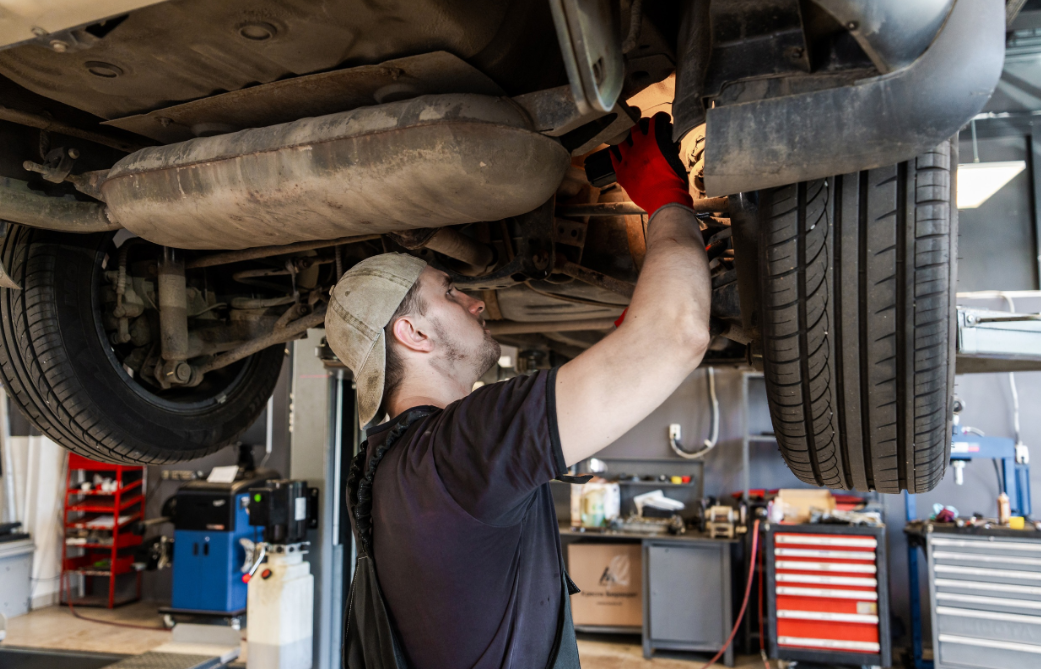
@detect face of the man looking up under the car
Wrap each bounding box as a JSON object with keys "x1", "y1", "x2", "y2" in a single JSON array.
[{"x1": 420, "y1": 267, "x2": 500, "y2": 381}]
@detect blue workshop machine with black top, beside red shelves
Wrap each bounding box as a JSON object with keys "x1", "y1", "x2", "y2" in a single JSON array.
[{"x1": 171, "y1": 472, "x2": 277, "y2": 614}]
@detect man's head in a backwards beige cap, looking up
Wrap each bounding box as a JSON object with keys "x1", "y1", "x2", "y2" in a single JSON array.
[{"x1": 326, "y1": 254, "x2": 500, "y2": 424}]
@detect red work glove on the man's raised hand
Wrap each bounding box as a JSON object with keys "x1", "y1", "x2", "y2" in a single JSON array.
[{"x1": 611, "y1": 111, "x2": 693, "y2": 215}]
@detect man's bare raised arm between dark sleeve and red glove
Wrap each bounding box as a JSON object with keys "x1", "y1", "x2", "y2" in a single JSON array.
[{"x1": 556, "y1": 203, "x2": 711, "y2": 466}]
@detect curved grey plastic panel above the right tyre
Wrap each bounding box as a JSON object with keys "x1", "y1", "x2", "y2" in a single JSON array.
[{"x1": 705, "y1": 0, "x2": 1005, "y2": 197}]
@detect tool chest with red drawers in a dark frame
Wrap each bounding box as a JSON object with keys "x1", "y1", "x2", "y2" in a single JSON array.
[{"x1": 764, "y1": 524, "x2": 891, "y2": 667}]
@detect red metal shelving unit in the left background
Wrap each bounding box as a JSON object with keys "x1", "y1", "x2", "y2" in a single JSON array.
[{"x1": 61, "y1": 454, "x2": 145, "y2": 609}]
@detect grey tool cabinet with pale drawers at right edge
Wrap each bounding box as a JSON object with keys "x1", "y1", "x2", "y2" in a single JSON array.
[{"x1": 925, "y1": 526, "x2": 1041, "y2": 669}]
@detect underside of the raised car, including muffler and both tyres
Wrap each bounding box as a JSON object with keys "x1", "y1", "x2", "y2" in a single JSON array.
[{"x1": 0, "y1": 0, "x2": 1004, "y2": 492}]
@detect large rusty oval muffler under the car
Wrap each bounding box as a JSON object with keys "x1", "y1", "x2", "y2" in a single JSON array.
[{"x1": 99, "y1": 95, "x2": 570, "y2": 250}]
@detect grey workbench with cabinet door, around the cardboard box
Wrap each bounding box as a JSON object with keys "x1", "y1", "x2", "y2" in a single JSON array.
[{"x1": 560, "y1": 525, "x2": 743, "y2": 667}]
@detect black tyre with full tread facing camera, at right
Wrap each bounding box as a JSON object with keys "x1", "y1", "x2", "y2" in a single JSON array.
[{"x1": 759, "y1": 141, "x2": 958, "y2": 493}]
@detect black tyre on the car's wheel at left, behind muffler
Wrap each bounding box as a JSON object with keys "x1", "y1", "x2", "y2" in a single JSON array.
[{"x1": 0, "y1": 225, "x2": 285, "y2": 464}]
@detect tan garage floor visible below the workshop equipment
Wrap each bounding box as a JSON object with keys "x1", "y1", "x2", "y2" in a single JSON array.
[{"x1": 0, "y1": 602, "x2": 762, "y2": 669}]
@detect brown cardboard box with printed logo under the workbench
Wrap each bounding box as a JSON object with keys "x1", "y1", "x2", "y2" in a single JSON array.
[{"x1": 567, "y1": 543, "x2": 643, "y2": 627}]
